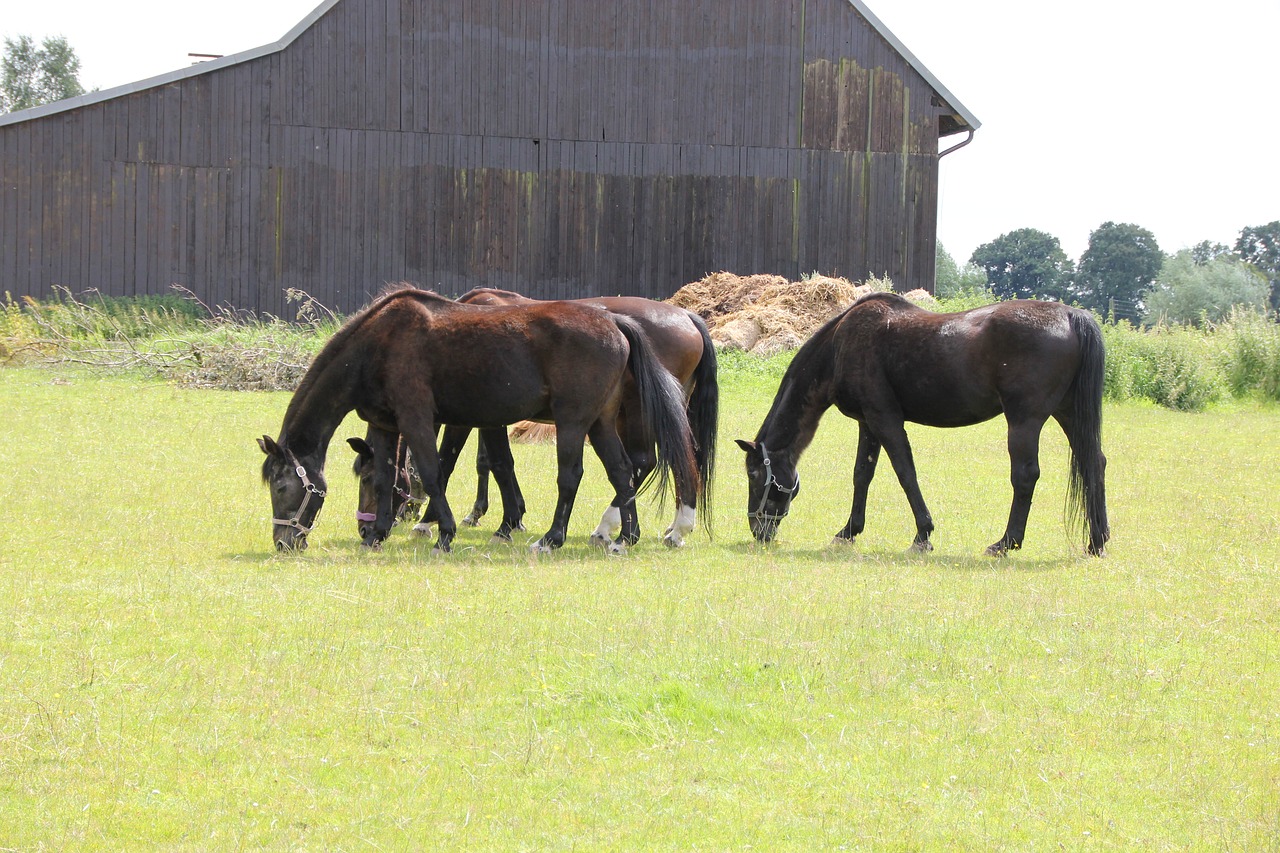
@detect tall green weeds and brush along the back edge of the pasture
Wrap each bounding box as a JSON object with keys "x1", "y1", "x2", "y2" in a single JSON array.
[{"x1": 0, "y1": 281, "x2": 1280, "y2": 411}]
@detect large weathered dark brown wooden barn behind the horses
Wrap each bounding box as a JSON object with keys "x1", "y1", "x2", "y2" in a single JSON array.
[{"x1": 0, "y1": 0, "x2": 978, "y2": 315}]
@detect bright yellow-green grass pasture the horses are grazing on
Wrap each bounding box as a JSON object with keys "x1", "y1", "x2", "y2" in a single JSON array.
[{"x1": 0, "y1": 369, "x2": 1280, "y2": 850}]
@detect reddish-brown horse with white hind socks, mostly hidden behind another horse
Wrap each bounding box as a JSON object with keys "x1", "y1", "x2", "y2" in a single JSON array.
[{"x1": 360, "y1": 287, "x2": 719, "y2": 547}]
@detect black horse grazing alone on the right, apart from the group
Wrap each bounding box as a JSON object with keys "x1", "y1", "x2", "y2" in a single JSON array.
[{"x1": 737, "y1": 293, "x2": 1111, "y2": 556}]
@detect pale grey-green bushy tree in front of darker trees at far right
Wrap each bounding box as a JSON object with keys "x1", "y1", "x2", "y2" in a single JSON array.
[{"x1": 1146, "y1": 248, "x2": 1270, "y2": 325}]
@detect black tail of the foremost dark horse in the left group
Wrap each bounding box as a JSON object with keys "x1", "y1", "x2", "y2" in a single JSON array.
[{"x1": 611, "y1": 314, "x2": 703, "y2": 512}]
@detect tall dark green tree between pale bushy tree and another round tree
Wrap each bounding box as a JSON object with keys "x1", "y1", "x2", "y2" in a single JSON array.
[{"x1": 1074, "y1": 222, "x2": 1165, "y2": 320}]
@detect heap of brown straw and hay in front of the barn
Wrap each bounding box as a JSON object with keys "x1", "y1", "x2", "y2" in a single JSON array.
[{"x1": 667, "y1": 273, "x2": 911, "y2": 356}]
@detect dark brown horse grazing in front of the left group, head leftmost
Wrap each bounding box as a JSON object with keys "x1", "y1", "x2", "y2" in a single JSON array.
[{"x1": 257, "y1": 286, "x2": 700, "y2": 552}]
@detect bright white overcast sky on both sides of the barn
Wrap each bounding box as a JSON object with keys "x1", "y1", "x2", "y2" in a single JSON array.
[{"x1": 0, "y1": 0, "x2": 1280, "y2": 264}]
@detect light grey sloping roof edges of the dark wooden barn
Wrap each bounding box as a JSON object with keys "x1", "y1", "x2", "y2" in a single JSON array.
[{"x1": 0, "y1": 0, "x2": 982, "y2": 136}]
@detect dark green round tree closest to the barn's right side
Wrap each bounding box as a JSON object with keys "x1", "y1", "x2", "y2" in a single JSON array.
[{"x1": 969, "y1": 228, "x2": 1073, "y2": 300}]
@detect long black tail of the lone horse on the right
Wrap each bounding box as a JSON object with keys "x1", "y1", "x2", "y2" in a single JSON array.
[{"x1": 1066, "y1": 310, "x2": 1111, "y2": 556}]
